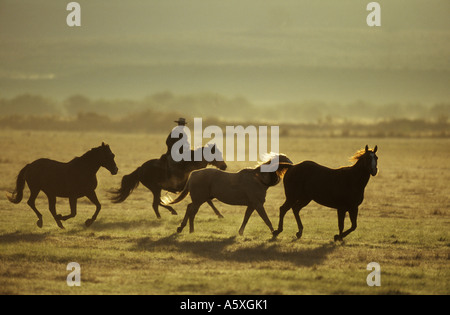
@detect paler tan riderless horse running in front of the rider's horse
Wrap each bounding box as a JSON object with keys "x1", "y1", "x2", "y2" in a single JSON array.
[{"x1": 167, "y1": 154, "x2": 292, "y2": 235}]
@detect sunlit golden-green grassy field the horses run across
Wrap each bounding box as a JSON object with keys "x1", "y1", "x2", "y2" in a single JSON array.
[{"x1": 0, "y1": 131, "x2": 450, "y2": 294}]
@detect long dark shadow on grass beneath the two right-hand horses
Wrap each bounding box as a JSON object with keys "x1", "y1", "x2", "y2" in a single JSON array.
[{"x1": 135, "y1": 233, "x2": 336, "y2": 267}]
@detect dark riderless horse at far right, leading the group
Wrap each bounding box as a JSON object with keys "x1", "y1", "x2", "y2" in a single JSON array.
[{"x1": 273, "y1": 145, "x2": 378, "y2": 241}]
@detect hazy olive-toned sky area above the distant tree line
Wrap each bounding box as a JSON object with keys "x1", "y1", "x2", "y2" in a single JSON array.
[{"x1": 0, "y1": 0, "x2": 450, "y2": 104}]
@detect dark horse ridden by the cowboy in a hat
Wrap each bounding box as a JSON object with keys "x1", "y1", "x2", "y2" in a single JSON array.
[{"x1": 112, "y1": 145, "x2": 227, "y2": 218}]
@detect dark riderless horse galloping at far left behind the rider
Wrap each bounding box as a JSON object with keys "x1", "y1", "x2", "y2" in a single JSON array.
[{"x1": 8, "y1": 143, "x2": 118, "y2": 229}]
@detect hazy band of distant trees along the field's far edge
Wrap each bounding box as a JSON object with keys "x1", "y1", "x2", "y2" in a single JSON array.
[{"x1": 0, "y1": 92, "x2": 450, "y2": 136}]
